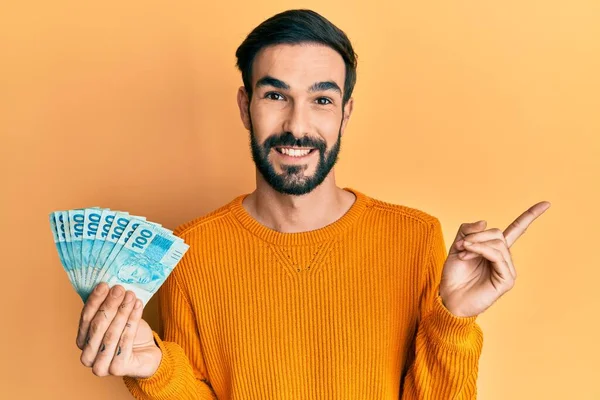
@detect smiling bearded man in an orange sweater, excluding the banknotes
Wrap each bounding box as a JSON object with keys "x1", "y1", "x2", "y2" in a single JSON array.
[{"x1": 77, "y1": 10, "x2": 550, "y2": 399}]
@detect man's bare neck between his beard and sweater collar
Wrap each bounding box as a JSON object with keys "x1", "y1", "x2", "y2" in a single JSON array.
[{"x1": 242, "y1": 173, "x2": 355, "y2": 233}]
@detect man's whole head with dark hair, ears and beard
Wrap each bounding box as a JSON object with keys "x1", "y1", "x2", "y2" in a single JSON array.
[{"x1": 236, "y1": 10, "x2": 356, "y2": 195}]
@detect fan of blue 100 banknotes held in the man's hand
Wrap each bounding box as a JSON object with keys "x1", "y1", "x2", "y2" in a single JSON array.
[{"x1": 50, "y1": 207, "x2": 189, "y2": 304}]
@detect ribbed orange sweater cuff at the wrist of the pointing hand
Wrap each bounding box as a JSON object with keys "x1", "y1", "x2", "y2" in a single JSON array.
[{"x1": 423, "y1": 294, "x2": 483, "y2": 352}]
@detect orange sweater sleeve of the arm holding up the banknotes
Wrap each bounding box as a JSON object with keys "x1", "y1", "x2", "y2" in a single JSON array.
[{"x1": 123, "y1": 266, "x2": 217, "y2": 400}]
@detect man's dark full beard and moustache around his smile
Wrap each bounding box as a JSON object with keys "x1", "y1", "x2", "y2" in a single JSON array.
[{"x1": 248, "y1": 111, "x2": 343, "y2": 196}]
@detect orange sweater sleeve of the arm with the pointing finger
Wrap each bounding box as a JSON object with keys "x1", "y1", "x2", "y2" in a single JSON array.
[{"x1": 401, "y1": 218, "x2": 483, "y2": 400}]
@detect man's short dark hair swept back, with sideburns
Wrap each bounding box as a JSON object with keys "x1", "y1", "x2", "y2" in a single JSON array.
[{"x1": 235, "y1": 9, "x2": 358, "y2": 107}]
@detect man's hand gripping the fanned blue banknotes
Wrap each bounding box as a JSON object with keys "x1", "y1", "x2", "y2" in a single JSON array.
[{"x1": 77, "y1": 282, "x2": 162, "y2": 378}]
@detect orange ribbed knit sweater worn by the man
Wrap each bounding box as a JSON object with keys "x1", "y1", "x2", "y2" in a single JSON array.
[{"x1": 124, "y1": 188, "x2": 483, "y2": 400}]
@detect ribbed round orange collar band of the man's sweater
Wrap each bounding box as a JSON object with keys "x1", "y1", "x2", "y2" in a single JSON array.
[{"x1": 230, "y1": 187, "x2": 369, "y2": 246}]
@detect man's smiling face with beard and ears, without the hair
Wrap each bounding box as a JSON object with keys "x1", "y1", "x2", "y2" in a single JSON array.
[{"x1": 238, "y1": 44, "x2": 352, "y2": 195}]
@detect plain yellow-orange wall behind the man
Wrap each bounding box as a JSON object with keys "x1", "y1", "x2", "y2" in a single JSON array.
[{"x1": 0, "y1": 0, "x2": 600, "y2": 400}]
